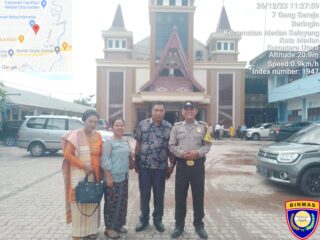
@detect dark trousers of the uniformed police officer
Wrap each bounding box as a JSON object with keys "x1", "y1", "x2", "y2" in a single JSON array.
[{"x1": 175, "y1": 160, "x2": 205, "y2": 228}]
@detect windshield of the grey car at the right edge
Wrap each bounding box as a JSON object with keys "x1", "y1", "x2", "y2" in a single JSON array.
[{"x1": 286, "y1": 124, "x2": 320, "y2": 145}]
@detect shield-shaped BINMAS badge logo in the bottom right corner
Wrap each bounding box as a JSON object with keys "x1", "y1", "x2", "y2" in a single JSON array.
[{"x1": 285, "y1": 200, "x2": 319, "y2": 239}]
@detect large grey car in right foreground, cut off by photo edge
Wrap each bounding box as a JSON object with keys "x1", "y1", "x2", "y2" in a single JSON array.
[{"x1": 257, "y1": 123, "x2": 320, "y2": 196}]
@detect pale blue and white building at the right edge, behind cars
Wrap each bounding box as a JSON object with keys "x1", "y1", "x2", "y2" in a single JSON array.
[{"x1": 250, "y1": 45, "x2": 320, "y2": 122}]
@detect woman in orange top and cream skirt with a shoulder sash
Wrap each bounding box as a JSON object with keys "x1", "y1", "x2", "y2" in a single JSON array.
[{"x1": 62, "y1": 110, "x2": 102, "y2": 240}]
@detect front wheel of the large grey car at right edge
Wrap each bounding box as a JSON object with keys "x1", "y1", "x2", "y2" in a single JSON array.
[{"x1": 300, "y1": 167, "x2": 320, "y2": 196}]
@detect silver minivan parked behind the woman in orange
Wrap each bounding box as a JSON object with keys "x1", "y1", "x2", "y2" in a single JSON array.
[{"x1": 18, "y1": 115, "x2": 84, "y2": 157}]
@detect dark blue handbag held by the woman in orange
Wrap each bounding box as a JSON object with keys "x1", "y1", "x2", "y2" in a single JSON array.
[{"x1": 75, "y1": 172, "x2": 105, "y2": 217}]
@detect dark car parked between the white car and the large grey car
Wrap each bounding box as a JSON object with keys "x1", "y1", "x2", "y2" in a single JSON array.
[{"x1": 271, "y1": 122, "x2": 311, "y2": 142}]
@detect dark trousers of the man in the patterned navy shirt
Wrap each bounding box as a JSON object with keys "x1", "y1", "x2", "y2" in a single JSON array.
[{"x1": 139, "y1": 167, "x2": 167, "y2": 223}]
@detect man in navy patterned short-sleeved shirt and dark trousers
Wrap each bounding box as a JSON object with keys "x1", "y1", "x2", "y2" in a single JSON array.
[{"x1": 135, "y1": 103, "x2": 174, "y2": 232}]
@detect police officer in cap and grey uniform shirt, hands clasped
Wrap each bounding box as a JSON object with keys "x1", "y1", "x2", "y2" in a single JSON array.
[{"x1": 169, "y1": 101, "x2": 211, "y2": 239}]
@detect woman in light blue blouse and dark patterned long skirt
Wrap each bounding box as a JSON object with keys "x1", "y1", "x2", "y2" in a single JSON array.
[{"x1": 101, "y1": 119, "x2": 133, "y2": 239}]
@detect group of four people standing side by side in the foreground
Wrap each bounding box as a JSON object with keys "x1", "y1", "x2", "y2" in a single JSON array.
[{"x1": 62, "y1": 101, "x2": 211, "y2": 240}]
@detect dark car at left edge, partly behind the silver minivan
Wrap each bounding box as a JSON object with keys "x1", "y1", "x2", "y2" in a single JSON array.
[{"x1": 0, "y1": 120, "x2": 23, "y2": 146}]
